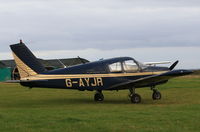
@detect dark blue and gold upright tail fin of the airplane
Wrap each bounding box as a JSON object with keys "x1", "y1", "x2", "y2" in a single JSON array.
[{"x1": 10, "y1": 41, "x2": 46, "y2": 78}]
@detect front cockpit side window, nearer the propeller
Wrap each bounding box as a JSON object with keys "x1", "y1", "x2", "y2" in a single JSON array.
[{"x1": 123, "y1": 60, "x2": 139, "y2": 72}]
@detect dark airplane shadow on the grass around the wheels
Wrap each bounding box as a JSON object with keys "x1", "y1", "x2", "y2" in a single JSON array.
[{"x1": 6, "y1": 98, "x2": 176, "y2": 108}]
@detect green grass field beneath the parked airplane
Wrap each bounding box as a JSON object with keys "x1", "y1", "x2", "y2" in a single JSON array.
[{"x1": 0, "y1": 77, "x2": 200, "y2": 132}]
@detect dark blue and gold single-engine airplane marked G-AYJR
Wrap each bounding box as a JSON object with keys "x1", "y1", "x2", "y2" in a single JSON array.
[{"x1": 10, "y1": 41, "x2": 193, "y2": 103}]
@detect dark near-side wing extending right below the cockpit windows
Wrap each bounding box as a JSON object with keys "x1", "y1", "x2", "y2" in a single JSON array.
[{"x1": 110, "y1": 70, "x2": 193, "y2": 90}]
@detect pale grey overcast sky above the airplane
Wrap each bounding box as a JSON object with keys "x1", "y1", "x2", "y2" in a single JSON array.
[{"x1": 0, "y1": 0, "x2": 200, "y2": 68}]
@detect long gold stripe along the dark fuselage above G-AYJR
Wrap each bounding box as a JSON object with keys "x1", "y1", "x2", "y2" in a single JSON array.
[{"x1": 21, "y1": 71, "x2": 167, "y2": 80}]
